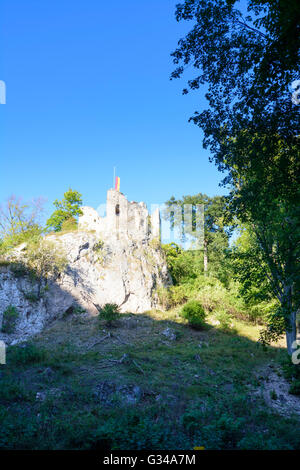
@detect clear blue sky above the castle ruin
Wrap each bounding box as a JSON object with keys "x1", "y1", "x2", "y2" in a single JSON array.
[{"x1": 0, "y1": 0, "x2": 229, "y2": 220}]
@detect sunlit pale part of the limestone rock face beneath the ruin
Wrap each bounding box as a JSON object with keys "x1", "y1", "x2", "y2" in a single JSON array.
[{"x1": 47, "y1": 232, "x2": 170, "y2": 313}]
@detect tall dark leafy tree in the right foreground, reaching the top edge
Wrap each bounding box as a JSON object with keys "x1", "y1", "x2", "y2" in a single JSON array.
[{"x1": 172, "y1": 0, "x2": 300, "y2": 354}]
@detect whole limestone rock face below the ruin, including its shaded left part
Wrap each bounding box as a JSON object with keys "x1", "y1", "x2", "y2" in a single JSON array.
[{"x1": 0, "y1": 231, "x2": 171, "y2": 344}]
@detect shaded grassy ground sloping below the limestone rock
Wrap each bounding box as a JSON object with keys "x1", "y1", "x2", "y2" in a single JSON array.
[{"x1": 0, "y1": 310, "x2": 300, "y2": 450}]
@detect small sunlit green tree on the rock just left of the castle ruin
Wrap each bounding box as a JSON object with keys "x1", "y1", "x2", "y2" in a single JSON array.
[{"x1": 46, "y1": 188, "x2": 82, "y2": 232}]
